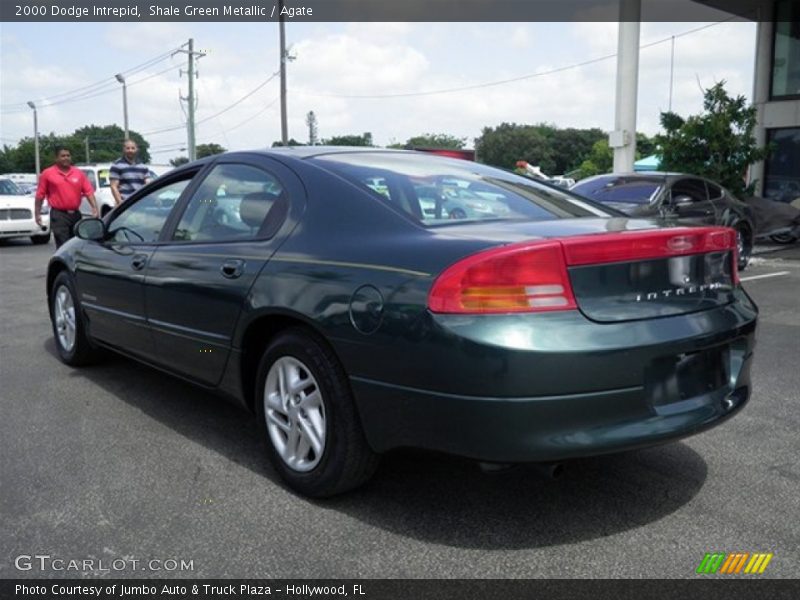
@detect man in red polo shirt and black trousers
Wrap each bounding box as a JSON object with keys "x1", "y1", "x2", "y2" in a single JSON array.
[{"x1": 34, "y1": 146, "x2": 98, "y2": 250}]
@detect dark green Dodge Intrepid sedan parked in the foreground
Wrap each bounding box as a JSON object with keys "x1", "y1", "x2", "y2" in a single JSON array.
[{"x1": 47, "y1": 147, "x2": 757, "y2": 496}]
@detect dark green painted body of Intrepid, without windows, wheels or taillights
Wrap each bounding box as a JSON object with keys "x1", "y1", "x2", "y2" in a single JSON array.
[{"x1": 47, "y1": 148, "x2": 757, "y2": 462}]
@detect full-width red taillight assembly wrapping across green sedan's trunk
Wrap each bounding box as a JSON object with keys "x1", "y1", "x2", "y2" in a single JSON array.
[{"x1": 428, "y1": 227, "x2": 739, "y2": 314}]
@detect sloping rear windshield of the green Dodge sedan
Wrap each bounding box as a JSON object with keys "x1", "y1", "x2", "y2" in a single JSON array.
[{"x1": 309, "y1": 152, "x2": 609, "y2": 227}]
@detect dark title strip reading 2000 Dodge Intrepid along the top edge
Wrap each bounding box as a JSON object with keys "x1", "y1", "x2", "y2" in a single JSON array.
[{"x1": 0, "y1": 0, "x2": 771, "y2": 22}]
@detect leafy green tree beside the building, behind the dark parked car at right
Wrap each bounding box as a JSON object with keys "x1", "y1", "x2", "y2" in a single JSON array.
[{"x1": 655, "y1": 81, "x2": 769, "y2": 195}]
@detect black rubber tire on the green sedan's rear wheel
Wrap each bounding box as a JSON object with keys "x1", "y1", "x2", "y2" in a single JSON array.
[{"x1": 255, "y1": 328, "x2": 380, "y2": 498}]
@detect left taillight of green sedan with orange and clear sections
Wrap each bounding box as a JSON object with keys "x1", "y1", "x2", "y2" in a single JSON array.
[{"x1": 428, "y1": 241, "x2": 576, "y2": 314}]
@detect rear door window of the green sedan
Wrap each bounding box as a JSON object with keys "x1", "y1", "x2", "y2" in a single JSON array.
[{"x1": 173, "y1": 164, "x2": 288, "y2": 242}]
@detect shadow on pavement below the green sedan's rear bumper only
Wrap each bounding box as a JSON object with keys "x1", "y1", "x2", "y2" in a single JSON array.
[{"x1": 328, "y1": 442, "x2": 707, "y2": 550}]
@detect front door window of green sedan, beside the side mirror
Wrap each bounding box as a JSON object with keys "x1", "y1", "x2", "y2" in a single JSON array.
[{"x1": 108, "y1": 176, "x2": 191, "y2": 244}]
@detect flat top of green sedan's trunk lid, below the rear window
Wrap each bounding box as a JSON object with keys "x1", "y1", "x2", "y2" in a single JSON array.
[{"x1": 437, "y1": 217, "x2": 673, "y2": 244}]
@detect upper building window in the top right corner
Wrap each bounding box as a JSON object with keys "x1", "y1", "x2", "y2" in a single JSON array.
[{"x1": 772, "y1": 0, "x2": 800, "y2": 98}]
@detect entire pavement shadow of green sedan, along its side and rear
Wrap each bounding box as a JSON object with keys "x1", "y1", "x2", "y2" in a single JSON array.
[{"x1": 45, "y1": 339, "x2": 707, "y2": 549}]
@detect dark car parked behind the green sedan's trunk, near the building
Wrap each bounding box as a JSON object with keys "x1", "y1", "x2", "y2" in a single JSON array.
[{"x1": 571, "y1": 172, "x2": 755, "y2": 269}]
